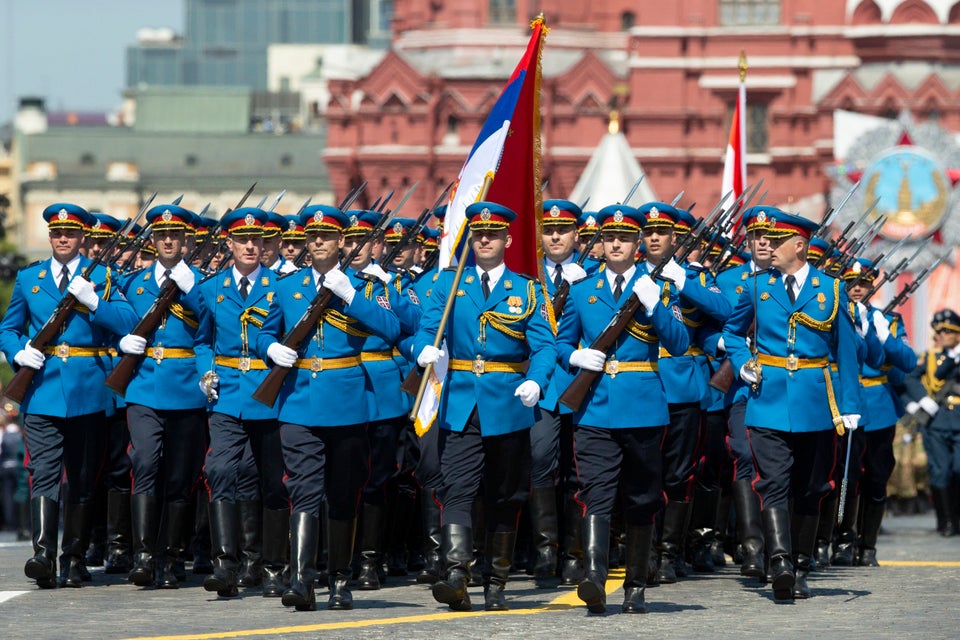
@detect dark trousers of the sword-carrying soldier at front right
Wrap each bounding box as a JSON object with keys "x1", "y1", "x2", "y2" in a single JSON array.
[{"x1": 747, "y1": 427, "x2": 837, "y2": 516}]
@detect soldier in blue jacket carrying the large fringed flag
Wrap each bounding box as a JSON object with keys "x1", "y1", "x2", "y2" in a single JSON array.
[{"x1": 413, "y1": 202, "x2": 556, "y2": 611}]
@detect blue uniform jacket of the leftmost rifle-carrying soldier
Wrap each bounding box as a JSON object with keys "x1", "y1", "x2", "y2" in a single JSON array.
[{"x1": 0, "y1": 258, "x2": 137, "y2": 418}]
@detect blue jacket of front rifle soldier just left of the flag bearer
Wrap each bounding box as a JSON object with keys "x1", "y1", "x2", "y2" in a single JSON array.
[{"x1": 257, "y1": 267, "x2": 400, "y2": 427}]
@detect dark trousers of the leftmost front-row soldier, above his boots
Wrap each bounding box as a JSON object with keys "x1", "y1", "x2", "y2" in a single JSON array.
[{"x1": 23, "y1": 411, "x2": 106, "y2": 504}]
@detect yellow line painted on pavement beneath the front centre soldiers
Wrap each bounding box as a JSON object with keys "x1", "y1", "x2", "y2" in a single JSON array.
[{"x1": 127, "y1": 570, "x2": 623, "y2": 640}]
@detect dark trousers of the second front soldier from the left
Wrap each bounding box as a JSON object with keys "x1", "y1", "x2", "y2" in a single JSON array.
[{"x1": 127, "y1": 404, "x2": 207, "y2": 502}]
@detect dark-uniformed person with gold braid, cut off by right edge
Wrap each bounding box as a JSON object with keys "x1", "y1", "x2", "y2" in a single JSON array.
[{"x1": 904, "y1": 309, "x2": 960, "y2": 536}]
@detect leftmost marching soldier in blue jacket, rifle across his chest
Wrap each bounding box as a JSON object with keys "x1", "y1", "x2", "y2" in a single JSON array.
[{"x1": 0, "y1": 204, "x2": 137, "y2": 589}]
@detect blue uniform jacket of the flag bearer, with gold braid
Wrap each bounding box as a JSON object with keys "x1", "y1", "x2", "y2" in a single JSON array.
[{"x1": 413, "y1": 267, "x2": 557, "y2": 436}]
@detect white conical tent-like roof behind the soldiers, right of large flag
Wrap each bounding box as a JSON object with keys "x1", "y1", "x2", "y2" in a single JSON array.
[{"x1": 569, "y1": 132, "x2": 657, "y2": 211}]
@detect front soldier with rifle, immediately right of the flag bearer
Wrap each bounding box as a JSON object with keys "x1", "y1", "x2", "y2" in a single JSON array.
[{"x1": 557, "y1": 205, "x2": 690, "y2": 613}]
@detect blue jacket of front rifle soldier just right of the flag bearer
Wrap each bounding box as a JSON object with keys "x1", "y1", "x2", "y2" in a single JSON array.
[{"x1": 557, "y1": 264, "x2": 690, "y2": 429}]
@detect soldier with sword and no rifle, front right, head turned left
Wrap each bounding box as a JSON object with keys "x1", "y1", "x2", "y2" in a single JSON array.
[{"x1": 723, "y1": 210, "x2": 860, "y2": 600}]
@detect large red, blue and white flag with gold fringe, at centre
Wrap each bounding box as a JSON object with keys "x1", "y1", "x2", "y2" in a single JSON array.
[{"x1": 414, "y1": 16, "x2": 552, "y2": 435}]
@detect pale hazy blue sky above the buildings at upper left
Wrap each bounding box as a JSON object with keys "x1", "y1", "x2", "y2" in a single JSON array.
[{"x1": 0, "y1": 0, "x2": 185, "y2": 124}]
